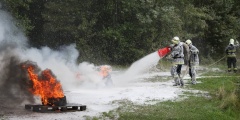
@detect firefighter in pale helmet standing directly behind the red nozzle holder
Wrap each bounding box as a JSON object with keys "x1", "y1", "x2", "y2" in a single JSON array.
[{"x1": 185, "y1": 39, "x2": 199, "y2": 85}]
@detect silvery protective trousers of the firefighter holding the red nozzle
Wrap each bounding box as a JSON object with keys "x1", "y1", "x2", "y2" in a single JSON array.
[{"x1": 171, "y1": 65, "x2": 184, "y2": 86}]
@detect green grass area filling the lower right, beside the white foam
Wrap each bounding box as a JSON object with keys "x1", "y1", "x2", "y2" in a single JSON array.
[{"x1": 94, "y1": 76, "x2": 240, "y2": 120}]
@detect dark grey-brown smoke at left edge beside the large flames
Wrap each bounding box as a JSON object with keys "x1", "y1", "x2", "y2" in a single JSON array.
[{"x1": 0, "y1": 45, "x2": 34, "y2": 111}]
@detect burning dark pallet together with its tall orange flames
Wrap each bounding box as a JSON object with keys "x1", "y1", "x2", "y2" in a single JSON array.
[{"x1": 23, "y1": 62, "x2": 86, "y2": 112}]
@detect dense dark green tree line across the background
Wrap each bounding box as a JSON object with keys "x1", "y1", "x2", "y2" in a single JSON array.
[{"x1": 1, "y1": 0, "x2": 240, "y2": 65}]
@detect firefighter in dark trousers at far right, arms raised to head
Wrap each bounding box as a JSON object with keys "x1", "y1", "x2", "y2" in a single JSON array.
[{"x1": 225, "y1": 39, "x2": 239, "y2": 73}]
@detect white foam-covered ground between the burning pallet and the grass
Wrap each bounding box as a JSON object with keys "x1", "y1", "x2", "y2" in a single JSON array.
[{"x1": 0, "y1": 72, "x2": 188, "y2": 120}]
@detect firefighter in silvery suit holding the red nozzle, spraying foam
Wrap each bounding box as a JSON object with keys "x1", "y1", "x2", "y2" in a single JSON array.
[{"x1": 170, "y1": 36, "x2": 184, "y2": 86}]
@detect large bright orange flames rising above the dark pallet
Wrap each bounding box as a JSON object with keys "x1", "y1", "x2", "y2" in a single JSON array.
[{"x1": 26, "y1": 65, "x2": 64, "y2": 105}]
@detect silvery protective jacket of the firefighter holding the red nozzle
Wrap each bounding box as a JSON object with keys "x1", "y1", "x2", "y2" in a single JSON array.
[{"x1": 170, "y1": 42, "x2": 184, "y2": 65}]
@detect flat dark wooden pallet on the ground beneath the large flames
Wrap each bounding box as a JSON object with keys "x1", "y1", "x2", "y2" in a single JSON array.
[{"x1": 25, "y1": 104, "x2": 87, "y2": 113}]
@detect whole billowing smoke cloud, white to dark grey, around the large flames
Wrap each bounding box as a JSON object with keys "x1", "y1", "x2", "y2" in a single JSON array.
[{"x1": 0, "y1": 3, "x2": 101, "y2": 111}]
